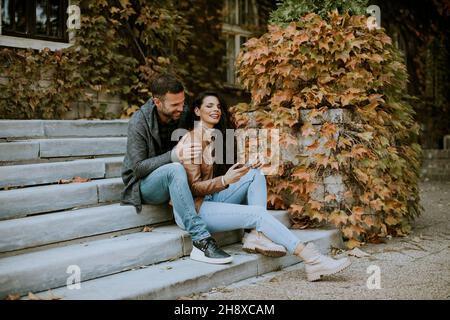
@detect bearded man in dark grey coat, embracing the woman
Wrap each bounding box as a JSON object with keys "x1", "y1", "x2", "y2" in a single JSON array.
[{"x1": 121, "y1": 75, "x2": 232, "y2": 264}]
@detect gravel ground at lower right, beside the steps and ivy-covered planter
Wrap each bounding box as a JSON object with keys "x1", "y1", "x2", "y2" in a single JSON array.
[{"x1": 191, "y1": 181, "x2": 450, "y2": 300}]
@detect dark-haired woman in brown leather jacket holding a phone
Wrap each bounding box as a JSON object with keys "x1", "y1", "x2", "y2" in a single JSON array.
[{"x1": 177, "y1": 92, "x2": 350, "y2": 281}]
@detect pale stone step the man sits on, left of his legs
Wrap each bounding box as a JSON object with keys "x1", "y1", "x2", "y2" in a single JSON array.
[{"x1": 0, "y1": 204, "x2": 173, "y2": 253}]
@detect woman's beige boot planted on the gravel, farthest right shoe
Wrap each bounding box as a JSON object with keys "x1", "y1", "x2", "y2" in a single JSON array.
[{"x1": 298, "y1": 242, "x2": 351, "y2": 281}]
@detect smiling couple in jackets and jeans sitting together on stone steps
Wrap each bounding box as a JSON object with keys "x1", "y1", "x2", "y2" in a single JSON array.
[{"x1": 121, "y1": 75, "x2": 350, "y2": 281}]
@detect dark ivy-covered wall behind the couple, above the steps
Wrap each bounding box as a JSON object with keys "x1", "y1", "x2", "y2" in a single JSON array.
[{"x1": 0, "y1": 0, "x2": 230, "y2": 119}]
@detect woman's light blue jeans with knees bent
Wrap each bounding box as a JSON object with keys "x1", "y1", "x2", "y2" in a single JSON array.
[{"x1": 174, "y1": 169, "x2": 301, "y2": 254}]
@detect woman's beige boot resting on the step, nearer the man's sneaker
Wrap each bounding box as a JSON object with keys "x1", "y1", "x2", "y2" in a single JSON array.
[{"x1": 242, "y1": 229, "x2": 286, "y2": 257}]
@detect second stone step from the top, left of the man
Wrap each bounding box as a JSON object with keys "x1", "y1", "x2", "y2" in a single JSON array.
[{"x1": 0, "y1": 137, "x2": 127, "y2": 162}]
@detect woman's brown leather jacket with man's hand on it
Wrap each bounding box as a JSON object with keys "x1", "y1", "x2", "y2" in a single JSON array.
[{"x1": 182, "y1": 128, "x2": 228, "y2": 213}]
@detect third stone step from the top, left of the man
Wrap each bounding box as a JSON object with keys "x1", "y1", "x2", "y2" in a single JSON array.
[{"x1": 0, "y1": 157, "x2": 123, "y2": 189}]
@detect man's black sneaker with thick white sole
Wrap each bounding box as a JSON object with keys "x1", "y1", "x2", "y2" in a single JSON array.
[{"x1": 191, "y1": 237, "x2": 233, "y2": 264}]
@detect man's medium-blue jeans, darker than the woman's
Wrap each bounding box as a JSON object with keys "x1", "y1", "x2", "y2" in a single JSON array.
[{"x1": 140, "y1": 162, "x2": 211, "y2": 241}]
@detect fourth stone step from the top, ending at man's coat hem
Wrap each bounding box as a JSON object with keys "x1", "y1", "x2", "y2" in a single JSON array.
[{"x1": 0, "y1": 178, "x2": 123, "y2": 220}]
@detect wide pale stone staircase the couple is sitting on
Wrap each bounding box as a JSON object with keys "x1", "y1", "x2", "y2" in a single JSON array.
[{"x1": 0, "y1": 120, "x2": 342, "y2": 299}]
